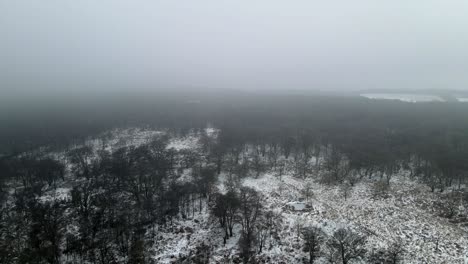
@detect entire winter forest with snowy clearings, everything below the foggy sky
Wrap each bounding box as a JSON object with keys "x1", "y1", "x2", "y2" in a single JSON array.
[{"x1": 0, "y1": 95, "x2": 468, "y2": 264}]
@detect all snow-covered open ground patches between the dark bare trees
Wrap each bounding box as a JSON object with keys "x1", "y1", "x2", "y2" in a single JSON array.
[{"x1": 28, "y1": 129, "x2": 468, "y2": 264}]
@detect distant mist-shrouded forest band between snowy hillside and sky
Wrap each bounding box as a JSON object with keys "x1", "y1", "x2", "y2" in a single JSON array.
[{"x1": 0, "y1": 90, "x2": 468, "y2": 158}]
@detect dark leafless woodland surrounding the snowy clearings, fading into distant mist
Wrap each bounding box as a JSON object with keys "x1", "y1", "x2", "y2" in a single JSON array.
[{"x1": 0, "y1": 95, "x2": 468, "y2": 264}]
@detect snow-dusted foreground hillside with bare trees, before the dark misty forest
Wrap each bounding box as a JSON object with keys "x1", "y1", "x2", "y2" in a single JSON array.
[{"x1": 0, "y1": 128, "x2": 468, "y2": 263}]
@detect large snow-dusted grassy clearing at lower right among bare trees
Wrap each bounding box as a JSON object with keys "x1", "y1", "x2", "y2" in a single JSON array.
[{"x1": 244, "y1": 174, "x2": 467, "y2": 263}]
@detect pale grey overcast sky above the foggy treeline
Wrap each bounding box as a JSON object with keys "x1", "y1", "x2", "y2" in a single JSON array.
[{"x1": 0, "y1": 0, "x2": 468, "y2": 95}]
